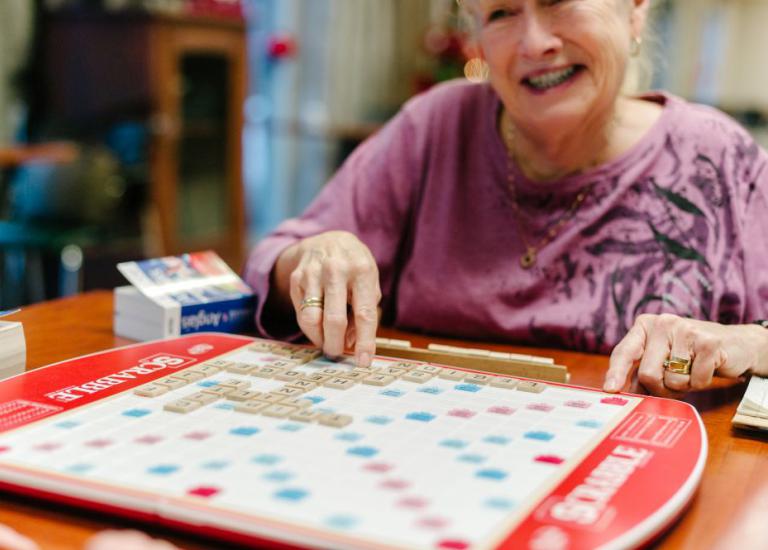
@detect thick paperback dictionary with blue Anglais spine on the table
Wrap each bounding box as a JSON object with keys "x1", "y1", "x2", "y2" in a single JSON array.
[{"x1": 114, "y1": 251, "x2": 254, "y2": 340}]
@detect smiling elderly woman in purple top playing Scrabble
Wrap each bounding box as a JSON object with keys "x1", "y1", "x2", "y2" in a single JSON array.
[{"x1": 246, "y1": 0, "x2": 768, "y2": 395}]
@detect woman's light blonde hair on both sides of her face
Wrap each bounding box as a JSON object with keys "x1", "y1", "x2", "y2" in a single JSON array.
[{"x1": 456, "y1": 0, "x2": 658, "y2": 95}]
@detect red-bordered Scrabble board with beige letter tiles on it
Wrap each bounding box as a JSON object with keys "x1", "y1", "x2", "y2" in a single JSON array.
[{"x1": 0, "y1": 333, "x2": 706, "y2": 550}]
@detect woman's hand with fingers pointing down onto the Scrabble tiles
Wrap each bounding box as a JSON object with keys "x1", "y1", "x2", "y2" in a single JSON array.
[{"x1": 273, "y1": 231, "x2": 381, "y2": 367}]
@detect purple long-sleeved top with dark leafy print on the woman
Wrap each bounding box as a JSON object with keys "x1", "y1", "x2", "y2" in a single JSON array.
[{"x1": 246, "y1": 82, "x2": 768, "y2": 352}]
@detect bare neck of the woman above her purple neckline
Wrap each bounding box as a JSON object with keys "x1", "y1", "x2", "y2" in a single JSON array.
[{"x1": 499, "y1": 98, "x2": 661, "y2": 181}]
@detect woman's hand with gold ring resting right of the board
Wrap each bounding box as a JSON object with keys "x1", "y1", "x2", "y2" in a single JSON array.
[{"x1": 603, "y1": 313, "x2": 768, "y2": 397}]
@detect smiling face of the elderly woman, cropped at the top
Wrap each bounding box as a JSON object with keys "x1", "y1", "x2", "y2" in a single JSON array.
[{"x1": 467, "y1": 0, "x2": 647, "y2": 131}]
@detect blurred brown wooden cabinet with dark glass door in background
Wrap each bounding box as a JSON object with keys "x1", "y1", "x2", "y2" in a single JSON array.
[{"x1": 45, "y1": 11, "x2": 246, "y2": 269}]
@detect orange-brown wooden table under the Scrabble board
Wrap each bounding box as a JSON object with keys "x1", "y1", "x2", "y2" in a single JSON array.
[{"x1": 0, "y1": 291, "x2": 768, "y2": 550}]
